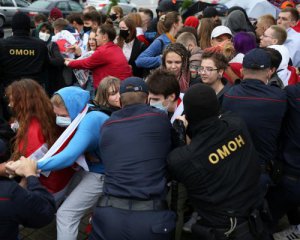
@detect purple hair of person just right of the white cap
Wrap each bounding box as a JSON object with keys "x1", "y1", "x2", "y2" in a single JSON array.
[{"x1": 233, "y1": 32, "x2": 256, "y2": 54}]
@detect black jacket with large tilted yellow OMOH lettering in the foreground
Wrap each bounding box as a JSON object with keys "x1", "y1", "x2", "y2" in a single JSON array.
[{"x1": 168, "y1": 113, "x2": 261, "y2": 227}]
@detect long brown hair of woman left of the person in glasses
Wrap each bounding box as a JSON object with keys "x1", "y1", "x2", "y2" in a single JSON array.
[{"x1": 162, "y1": 43, "x2": 190, "y2": 92}]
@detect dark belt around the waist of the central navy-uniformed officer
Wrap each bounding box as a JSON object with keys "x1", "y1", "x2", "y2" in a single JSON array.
[{"x1": 97, "y1": 196, "x2": 168, "y2": 211}]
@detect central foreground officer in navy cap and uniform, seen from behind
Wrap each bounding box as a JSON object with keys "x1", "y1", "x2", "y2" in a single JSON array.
[{"x1": 89, "y1": 77, "x2": 175, "y2": 240}]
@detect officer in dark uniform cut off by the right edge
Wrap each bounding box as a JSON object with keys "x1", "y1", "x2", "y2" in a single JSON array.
[{"x1": 267, "y1": 83, "x2": 300, "y2": 227}]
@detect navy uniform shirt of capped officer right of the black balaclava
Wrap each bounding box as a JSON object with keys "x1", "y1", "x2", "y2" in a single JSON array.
[{"x1": 222, "y1": 79, "x2": 287, "y2": 165}]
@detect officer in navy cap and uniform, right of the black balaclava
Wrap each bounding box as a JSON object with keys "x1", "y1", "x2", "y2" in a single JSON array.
[{"x1": 222, "y1": 48, "x2": 287, "y2": 194}]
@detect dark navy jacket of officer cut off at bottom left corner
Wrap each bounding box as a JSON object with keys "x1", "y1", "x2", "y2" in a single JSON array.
[{"x1": 0, "y1": 176, "x2": 55, "y2": 240}]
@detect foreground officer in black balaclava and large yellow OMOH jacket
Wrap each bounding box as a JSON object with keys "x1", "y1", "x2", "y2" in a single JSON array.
[{"x1": 168, "y1": 84, "x2": 268, "y2": 240}]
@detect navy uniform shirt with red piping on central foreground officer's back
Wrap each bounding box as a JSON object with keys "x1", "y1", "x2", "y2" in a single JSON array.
[{"x1": 100, "y1": 104, "x2": 171, "y2": 200}]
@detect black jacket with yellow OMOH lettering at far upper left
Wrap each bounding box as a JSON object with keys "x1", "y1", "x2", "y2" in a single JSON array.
[{"x1": 0, "y1": 32, "x2": 48, "y2": 88}]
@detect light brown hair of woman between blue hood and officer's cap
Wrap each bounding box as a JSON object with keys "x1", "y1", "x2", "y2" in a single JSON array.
[{"x1": 94, "y1": 76, "x2": 121, "y2": 107}]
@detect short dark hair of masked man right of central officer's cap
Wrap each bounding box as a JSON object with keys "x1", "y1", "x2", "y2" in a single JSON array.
[{"x1": 146, "y1": 68, "x2": 180, "y2": 100}]
